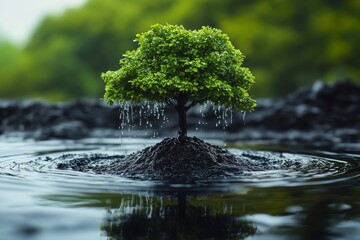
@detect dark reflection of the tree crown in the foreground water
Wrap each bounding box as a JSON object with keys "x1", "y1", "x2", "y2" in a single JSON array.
[{"x1": 101, "y1": 194, "x2": 256, "y2": 239}]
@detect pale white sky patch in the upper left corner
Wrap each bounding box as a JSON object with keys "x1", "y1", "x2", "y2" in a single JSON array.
[{"x1": 0, "y1": 0, "x2": 86, "y2": 43}]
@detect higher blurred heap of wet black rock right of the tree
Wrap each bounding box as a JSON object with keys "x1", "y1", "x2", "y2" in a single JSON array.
[{"x1": 248, "y1": 81, "x2": 360, "y2": 130}]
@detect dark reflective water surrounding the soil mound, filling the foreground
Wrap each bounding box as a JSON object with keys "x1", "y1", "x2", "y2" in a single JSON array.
[{"x1": 0, "y1": 138, "x2": 360, "y2": 240}]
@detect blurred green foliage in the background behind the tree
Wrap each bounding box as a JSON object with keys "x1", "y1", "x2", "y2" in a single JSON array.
[{"x1": 0, "y1": 0, "x2": 360, "y2": 101}]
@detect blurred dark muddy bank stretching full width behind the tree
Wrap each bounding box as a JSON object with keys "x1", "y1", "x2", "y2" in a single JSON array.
[{"x1": 0, "y1": 81, "x2": 360, "y2": 143}]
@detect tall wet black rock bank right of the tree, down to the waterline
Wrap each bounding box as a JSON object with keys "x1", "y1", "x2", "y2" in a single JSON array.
[{"x1": 225, "y1": 80, "x2": 360, "y2": 145}]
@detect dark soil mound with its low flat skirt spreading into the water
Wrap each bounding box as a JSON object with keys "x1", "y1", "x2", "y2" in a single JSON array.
[{"x1": 53, "y1": 137, "x2": 275, "y2": 180}]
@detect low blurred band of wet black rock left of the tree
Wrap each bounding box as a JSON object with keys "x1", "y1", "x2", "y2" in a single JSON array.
[{"x1": 0, "y1": 100, "x2": 119, "y2": 140}]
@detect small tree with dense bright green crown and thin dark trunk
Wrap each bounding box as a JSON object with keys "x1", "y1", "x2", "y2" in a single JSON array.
[{"x1": 102, "y1": 24, "x2": 256, "y2": 136}]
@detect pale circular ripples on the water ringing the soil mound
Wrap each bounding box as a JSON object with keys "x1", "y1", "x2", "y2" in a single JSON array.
[{"x1": 0, "y1": 140, "x2": 360, "y2": 192}]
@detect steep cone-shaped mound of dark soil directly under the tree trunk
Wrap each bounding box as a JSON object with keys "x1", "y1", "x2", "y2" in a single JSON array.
[{"x1": 107, "y1": 137, "x2": 248, "y2": 178}]
